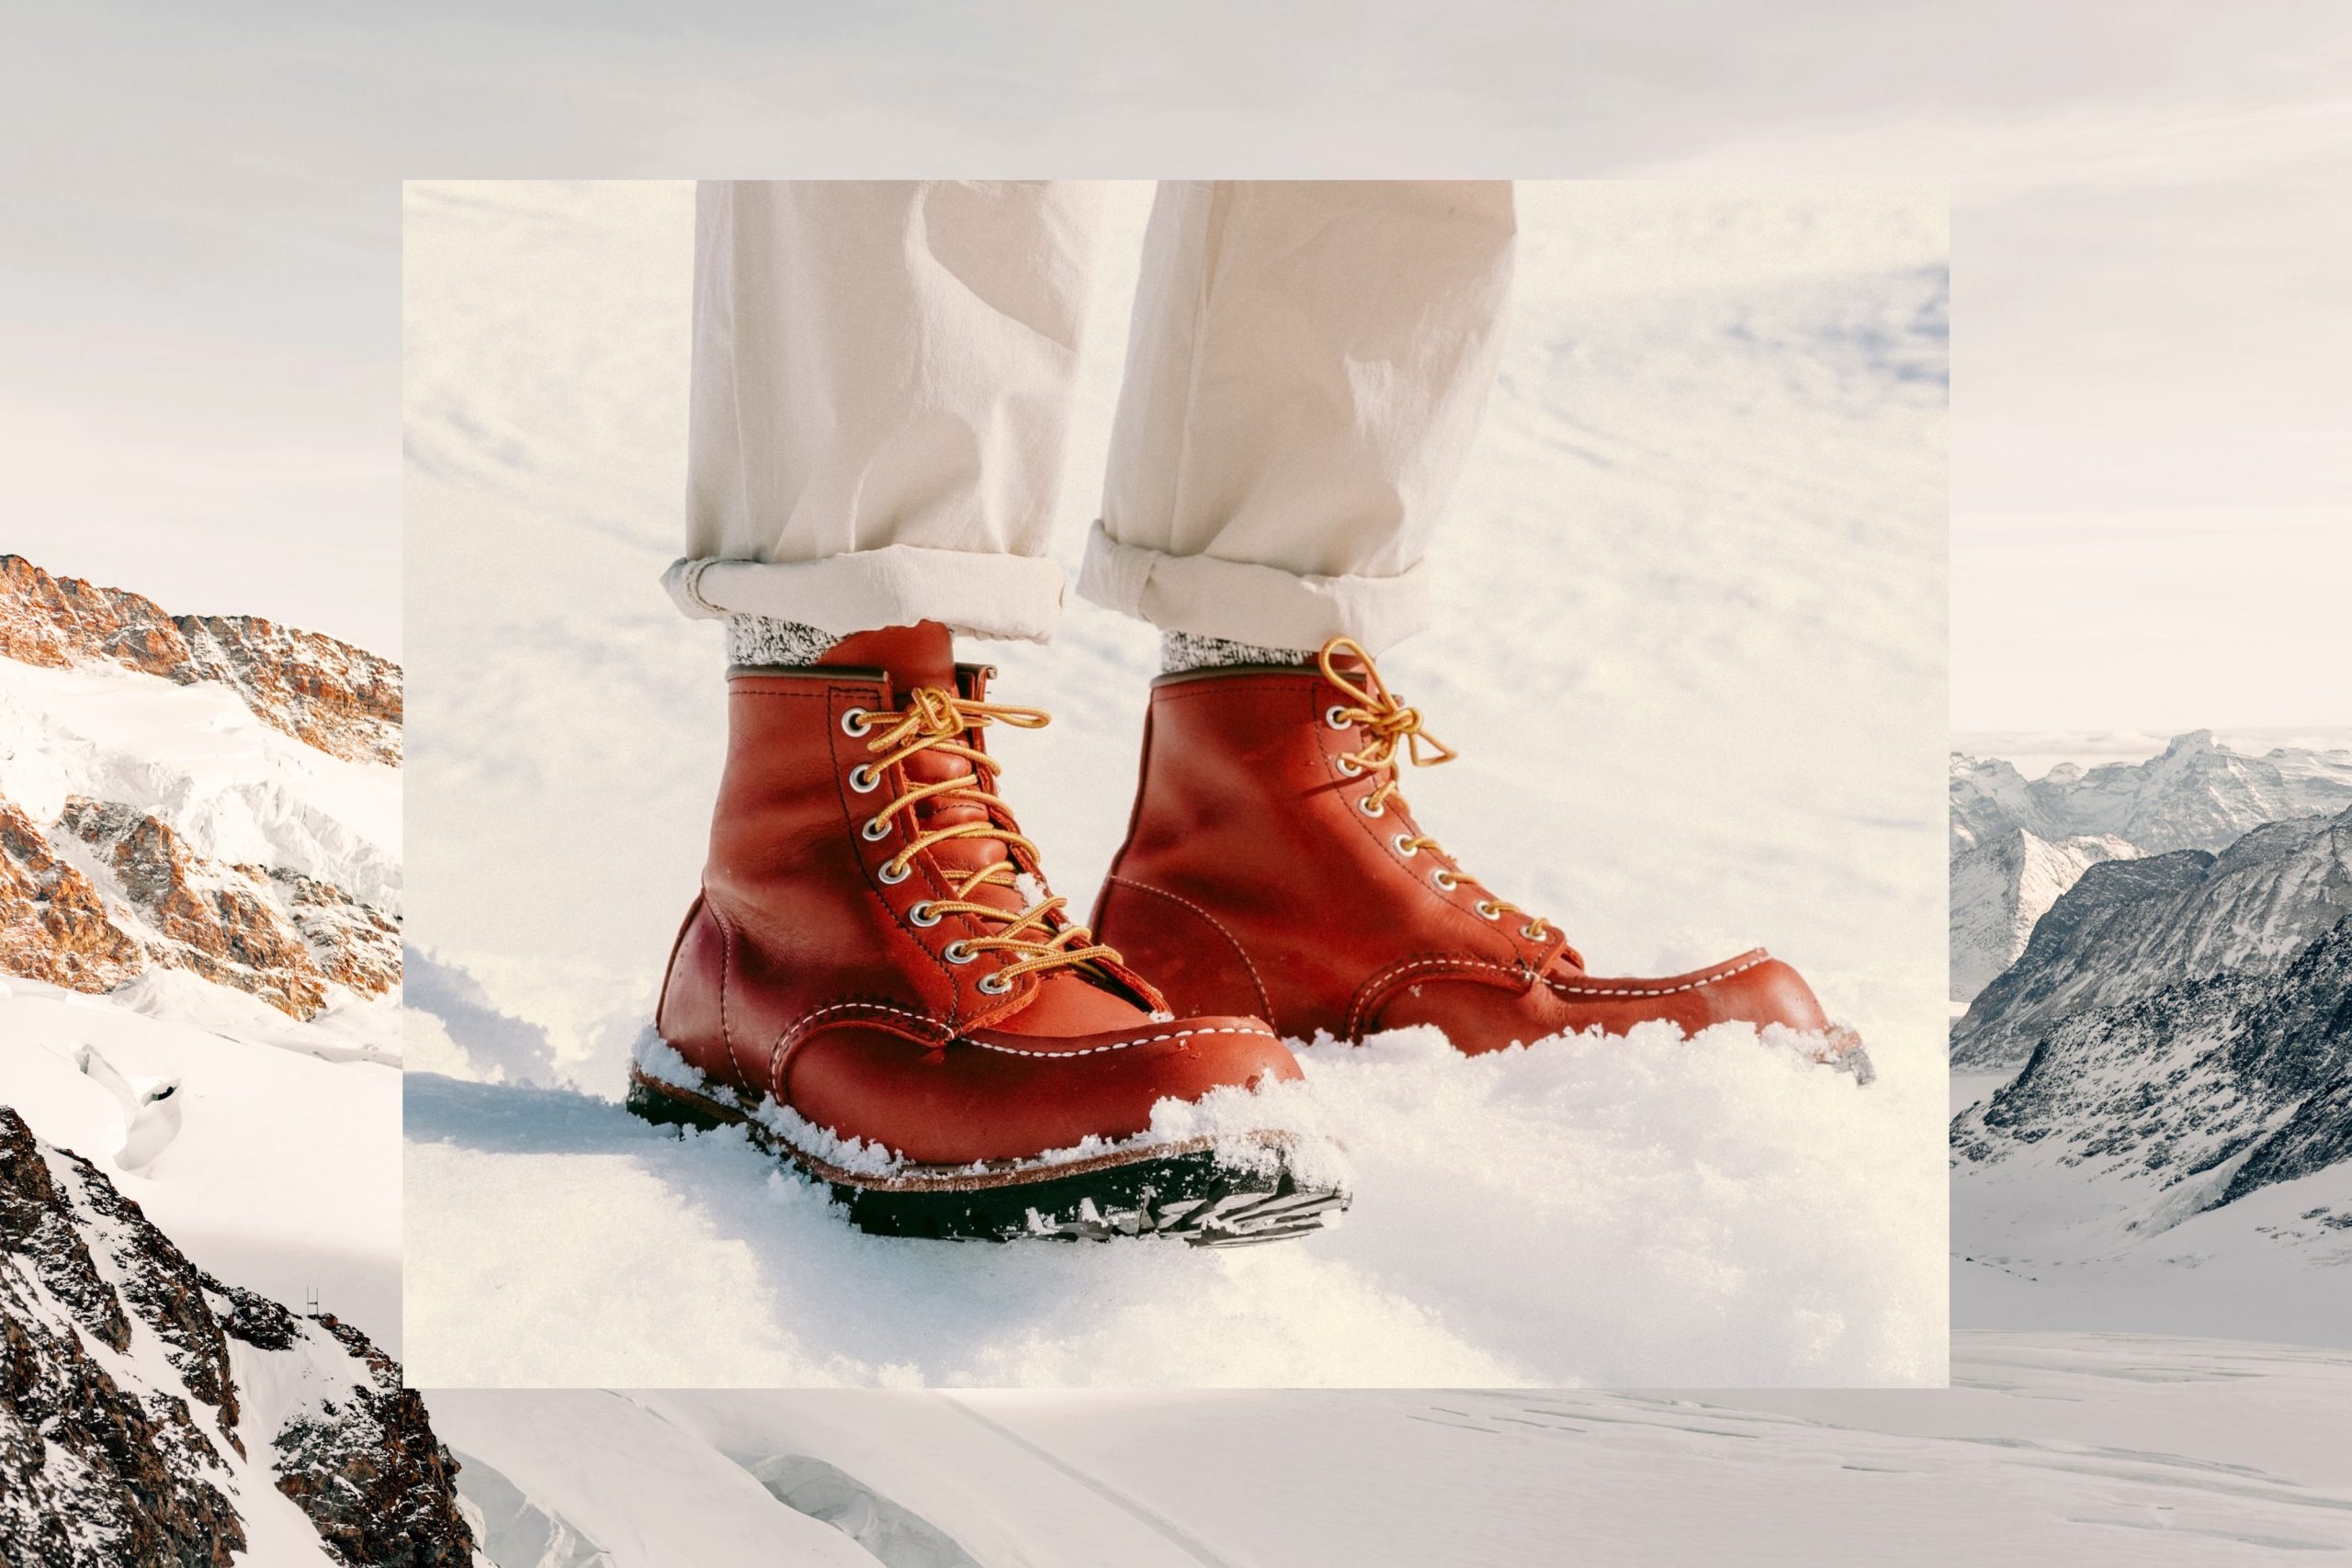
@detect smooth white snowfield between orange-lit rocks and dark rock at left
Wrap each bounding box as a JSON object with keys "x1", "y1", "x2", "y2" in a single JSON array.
[{"x1": 0, "y1": 974, "x2": 400, "y2": 1354}]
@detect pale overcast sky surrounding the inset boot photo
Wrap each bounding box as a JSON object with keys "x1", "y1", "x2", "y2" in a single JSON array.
[{"x1": 0, "y1": 0, "x2": 2352, "y2": 731}]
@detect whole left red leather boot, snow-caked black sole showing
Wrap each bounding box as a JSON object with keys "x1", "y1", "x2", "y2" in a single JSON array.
[{"x1": 630, "y1": 621, "x2": 1345, "y2": 1244}]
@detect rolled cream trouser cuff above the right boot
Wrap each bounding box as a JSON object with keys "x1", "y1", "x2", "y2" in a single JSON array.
[{"x1": 1077, "y1": 522, "x2": 1430, "y2": 653}]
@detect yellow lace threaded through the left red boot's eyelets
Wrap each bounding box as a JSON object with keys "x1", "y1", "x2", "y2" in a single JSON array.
[{"x1": 842, "y1": 686, "x2": 1120, "y2": 995}]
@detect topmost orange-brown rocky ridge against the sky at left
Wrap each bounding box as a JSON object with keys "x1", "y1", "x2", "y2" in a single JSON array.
[{"x1": 0, "y1": 555, "x2": 402, "y2": 766}]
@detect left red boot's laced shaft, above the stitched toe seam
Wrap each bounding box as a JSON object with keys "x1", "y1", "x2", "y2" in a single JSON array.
[{"x1": 656, "y1": 623, "x2": 1162, "y2": 1086}]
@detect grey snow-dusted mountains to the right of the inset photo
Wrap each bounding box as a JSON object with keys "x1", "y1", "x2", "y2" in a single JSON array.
[{"x1": 1950, "y1": 733, "x2": 2352, "y2": 1345}]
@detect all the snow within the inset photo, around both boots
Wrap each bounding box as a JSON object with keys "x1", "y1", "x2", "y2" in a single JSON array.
[{"x1": 404, "y1": 184, "x2": 1948, "y2": 1384}]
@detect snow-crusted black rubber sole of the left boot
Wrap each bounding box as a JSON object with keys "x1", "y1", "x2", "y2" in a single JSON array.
[{"x1": 628, "y1": 1072, "x2": 1348, "y2": 1246}]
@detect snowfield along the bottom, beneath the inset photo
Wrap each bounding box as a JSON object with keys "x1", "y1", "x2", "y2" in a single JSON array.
[{"x1": 425, "y1": 1333, "x2": 2352, "y2": 1568}]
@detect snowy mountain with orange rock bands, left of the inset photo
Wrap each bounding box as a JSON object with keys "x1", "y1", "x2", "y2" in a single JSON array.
[{"x1": 0, "y1": 558, "x2": 402, "y2": 1354}]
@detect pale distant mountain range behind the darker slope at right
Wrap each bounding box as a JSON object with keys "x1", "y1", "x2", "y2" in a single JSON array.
[{"x1": 1950, "y1": 728, "x2": 2352, "y2": 856}]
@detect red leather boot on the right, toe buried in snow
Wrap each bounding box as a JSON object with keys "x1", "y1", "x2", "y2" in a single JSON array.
[{"x1": 1093, "y1": 637, "x2": 1868, "y2": 1081}]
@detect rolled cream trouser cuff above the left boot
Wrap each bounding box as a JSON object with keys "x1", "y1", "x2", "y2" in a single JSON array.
[{"x1": 661, "y1": 546, "x2": 1063, "y2": 642}]
